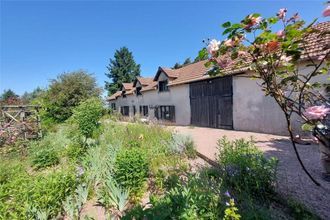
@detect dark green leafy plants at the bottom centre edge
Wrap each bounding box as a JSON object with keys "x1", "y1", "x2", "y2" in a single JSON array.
[{"x1": 123, "y1": 176, "x2": 223, "y2": 219}]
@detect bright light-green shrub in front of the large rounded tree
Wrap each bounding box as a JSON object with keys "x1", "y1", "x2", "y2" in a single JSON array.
[{"x1": 72, "y1": 98, "x2": 104, "y2": 137}]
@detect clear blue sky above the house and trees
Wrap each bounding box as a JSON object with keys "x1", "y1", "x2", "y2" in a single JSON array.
[{"x1": 0, "y1": 0, "x2": 325, "y2": 94}]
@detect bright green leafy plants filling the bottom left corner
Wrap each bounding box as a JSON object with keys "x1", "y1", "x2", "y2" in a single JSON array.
[{"x1": 0, "y1": 169, "x2": 76, "y2": 219}]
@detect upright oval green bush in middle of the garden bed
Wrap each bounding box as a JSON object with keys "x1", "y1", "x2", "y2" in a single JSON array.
[{"x1": 114, "y1": 147, "x2": 149, "y2": 197}]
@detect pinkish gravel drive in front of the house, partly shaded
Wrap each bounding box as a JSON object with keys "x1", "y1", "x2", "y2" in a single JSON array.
[{"x1": 174, "y1": 126, "x2": 330, "y2": 219}]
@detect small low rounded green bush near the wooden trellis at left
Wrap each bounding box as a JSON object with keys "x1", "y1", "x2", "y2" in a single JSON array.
[{"x1": 32, "y1": 148, "x2": 60, "y2": 169}]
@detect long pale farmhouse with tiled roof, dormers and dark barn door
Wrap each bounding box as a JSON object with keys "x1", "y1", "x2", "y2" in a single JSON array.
[{"x1": 109, "y1": 22, "x2": 330, "y2": 134}]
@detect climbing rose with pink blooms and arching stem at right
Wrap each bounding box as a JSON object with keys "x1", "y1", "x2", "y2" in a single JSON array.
[{"x1": 200, "y1": 7, "x2": 330, "y2": 185}]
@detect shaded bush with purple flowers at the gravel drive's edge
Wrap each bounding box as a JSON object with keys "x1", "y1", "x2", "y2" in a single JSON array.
[{"x1": 218, "y1": 137, "x2": 278, "y2": 198}]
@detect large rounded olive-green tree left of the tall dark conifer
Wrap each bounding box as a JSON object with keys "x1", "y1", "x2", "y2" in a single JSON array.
[{"x1": 40, "y1": 70, "x2": 101, "y2": 122}]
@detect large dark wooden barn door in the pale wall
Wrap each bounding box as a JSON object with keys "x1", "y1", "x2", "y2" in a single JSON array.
[{"x1": 190, "y1": 76, "x2": 233, "y2": 129}]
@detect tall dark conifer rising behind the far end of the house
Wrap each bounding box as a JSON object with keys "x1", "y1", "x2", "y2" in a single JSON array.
[{"x1": 105, "y1": 47, "x2": 141, "y2": 95}]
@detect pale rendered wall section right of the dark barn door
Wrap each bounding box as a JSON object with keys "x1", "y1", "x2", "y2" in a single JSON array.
[{"x1": 233, "y1": 76, "x2": 286, "y2": 134}]
